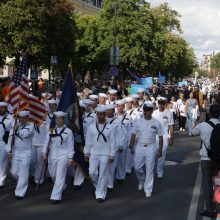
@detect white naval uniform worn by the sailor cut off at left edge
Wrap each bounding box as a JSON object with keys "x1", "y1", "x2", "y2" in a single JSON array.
[{"x1": 0, "y1": 114, "x2": 13, "y2": 186}]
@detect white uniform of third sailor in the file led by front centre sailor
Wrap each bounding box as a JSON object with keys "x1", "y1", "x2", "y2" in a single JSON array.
[{"x1": 115, "y1": 113, "x2": 133, "y2": 180}]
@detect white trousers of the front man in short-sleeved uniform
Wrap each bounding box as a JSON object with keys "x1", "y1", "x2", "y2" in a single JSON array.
[{"x1": 134, "y1": 144, "x2": 156, "y2": 194}]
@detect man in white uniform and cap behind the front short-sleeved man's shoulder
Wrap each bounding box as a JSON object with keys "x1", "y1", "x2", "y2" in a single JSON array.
[{"x1": 152, "y1": 97, "x2": 174, "y2": 178}]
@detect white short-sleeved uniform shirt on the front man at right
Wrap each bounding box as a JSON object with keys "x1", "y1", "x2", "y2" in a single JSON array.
[{"x1": 132, "y1": 118, "x2": 163, "y2": 147}]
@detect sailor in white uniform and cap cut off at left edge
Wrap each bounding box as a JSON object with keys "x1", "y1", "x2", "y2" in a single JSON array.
[{"x1": 0, "y1": 102, "x2": 13, "y2": 189}]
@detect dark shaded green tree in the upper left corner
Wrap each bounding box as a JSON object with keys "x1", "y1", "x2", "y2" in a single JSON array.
[{"x1": 0, "y1": 0, "x2": 75, "y2": 67}]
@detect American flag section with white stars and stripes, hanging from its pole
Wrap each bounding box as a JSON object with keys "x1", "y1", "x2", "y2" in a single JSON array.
[{"x1": 9, "y1": 56, "x2": 29, "y2": 114}]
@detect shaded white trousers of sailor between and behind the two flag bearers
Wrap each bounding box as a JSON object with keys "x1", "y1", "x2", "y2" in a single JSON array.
[{"x1": 31, "y1": 146, "x2": 44, "y2": 184}]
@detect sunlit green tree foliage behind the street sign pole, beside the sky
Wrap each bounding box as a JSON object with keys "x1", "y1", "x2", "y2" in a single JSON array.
[{"x1": 76, "y1": 0, "x2": 196, "y2": 76}]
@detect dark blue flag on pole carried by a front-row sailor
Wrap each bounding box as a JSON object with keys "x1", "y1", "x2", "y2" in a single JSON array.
[{"x1": 54, "y1": 69, "x2": 89, "y2": 176}]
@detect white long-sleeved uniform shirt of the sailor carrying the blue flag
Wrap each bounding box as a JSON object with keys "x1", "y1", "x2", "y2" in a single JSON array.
[{"x1": 42, "y1": 126, "x2": 74, "y2": 160}]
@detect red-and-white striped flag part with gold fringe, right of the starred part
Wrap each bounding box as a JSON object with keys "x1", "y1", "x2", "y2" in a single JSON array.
[{"x1": 28, "y1": 95, "x2": 47, "y2": 125}]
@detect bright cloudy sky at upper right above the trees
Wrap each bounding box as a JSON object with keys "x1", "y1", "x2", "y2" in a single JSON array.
[{"x1": 147, "y1": 0, "x2": 220, "y2": 61}]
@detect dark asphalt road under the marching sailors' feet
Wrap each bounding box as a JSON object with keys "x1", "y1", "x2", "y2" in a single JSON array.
[{"x1": 0, "y1": 132, "x2": 200, "y2": 220}]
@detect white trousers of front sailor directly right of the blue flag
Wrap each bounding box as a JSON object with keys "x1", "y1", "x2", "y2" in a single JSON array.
[{"x1": 89, "y1": 155, "x2": 109, "y2": 199}]
